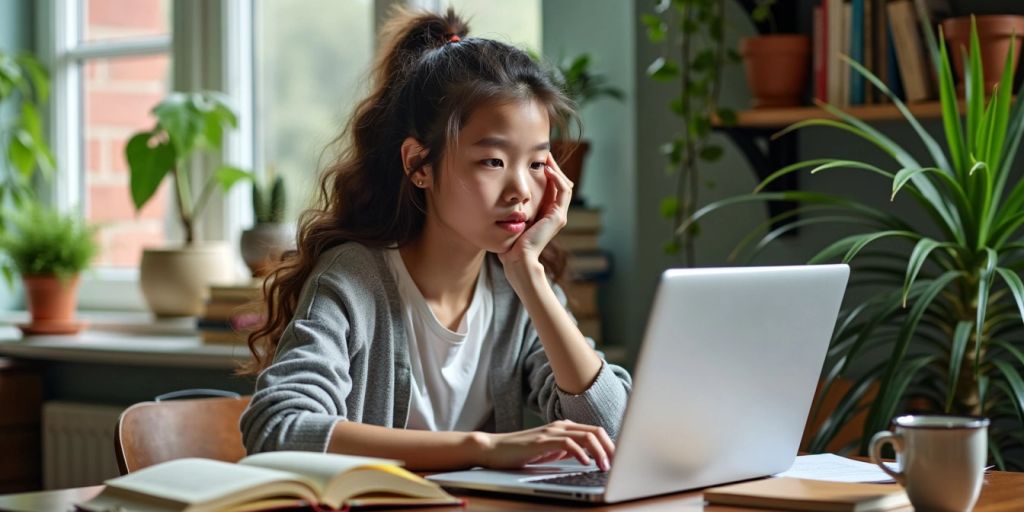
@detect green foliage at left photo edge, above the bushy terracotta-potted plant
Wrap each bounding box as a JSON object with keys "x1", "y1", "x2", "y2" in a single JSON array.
[{"x1": 0, "y1": 50, "x2": 55, "y2": 216}]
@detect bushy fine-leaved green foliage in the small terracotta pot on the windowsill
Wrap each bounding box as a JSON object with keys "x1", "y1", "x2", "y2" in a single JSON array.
[{"x1": 0, "y1": 202, "x2": 98, "y2": 284}]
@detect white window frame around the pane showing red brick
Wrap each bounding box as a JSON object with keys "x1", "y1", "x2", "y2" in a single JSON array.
[{"x1": 36, "y1": 0, "x2": 253, "y2": 310}]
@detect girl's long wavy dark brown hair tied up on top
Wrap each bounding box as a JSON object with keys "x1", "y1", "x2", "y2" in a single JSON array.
[{"x1": 240, "y1": 8, "x2": 580, "y2": 375}]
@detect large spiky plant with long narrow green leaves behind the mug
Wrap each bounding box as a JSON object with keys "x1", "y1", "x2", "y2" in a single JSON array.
[{"x1": 680, "y1": 18, "x2": 1024, "y2": 469}]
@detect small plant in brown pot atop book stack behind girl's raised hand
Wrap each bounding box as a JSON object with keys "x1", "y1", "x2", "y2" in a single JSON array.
[{"x1": 551, "y1": 53, "x2": 624, "y2": 203}]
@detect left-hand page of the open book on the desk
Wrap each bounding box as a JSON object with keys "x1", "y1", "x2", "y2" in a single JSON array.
[{"x1": 90, "y1": 459, "x2": 315, "y2": 508}]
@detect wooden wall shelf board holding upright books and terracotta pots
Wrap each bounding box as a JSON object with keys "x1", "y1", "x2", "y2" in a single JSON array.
[{"x1": 715, "y1": 101, "x2": 942, "y2": 128}]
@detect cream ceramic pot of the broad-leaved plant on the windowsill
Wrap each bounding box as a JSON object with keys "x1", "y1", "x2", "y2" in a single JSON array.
[{"x1": 139, "y1": 242, "x2": 239, "y2": 316}]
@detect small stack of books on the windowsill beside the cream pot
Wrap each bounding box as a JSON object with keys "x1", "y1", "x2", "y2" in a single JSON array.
[{"x1": 196, "y1": 280, "x2": 263, "y2": 344}]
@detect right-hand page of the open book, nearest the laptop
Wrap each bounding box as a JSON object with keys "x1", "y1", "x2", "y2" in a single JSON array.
[{"x1": 239, "y1": 452, "x2": 402, "y2": 496}]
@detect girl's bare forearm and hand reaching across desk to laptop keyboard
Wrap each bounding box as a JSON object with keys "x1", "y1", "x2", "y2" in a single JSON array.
[{"x1": 328, "y1": 421, "x2": 615, "y2": 471}]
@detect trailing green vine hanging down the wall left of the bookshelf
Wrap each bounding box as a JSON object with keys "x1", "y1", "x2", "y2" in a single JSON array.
[{"x1": 642, "y1": 0, "x2": 740, "y2": 264}]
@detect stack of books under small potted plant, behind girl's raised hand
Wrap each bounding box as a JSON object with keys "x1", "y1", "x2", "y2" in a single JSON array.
[{"x1": 555, "y1": 206, "x2": 611, "y2": 343}]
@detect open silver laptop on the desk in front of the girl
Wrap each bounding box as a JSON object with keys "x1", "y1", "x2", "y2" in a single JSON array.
[{"x1": 428, "y1": 265, "x2": 850, "y2": 503}]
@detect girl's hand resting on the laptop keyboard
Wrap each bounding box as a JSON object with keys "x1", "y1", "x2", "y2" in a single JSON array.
[{"x1": 468, "y1": 420, "x2": 615, "y2": 471}]
